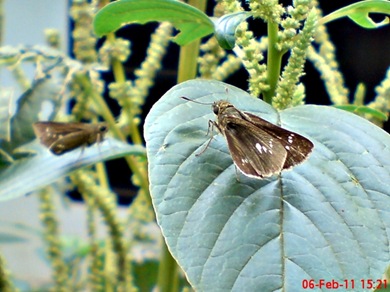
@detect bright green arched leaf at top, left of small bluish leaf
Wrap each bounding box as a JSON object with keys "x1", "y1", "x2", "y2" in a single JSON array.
[{"x1": 94, "y1": 0, "x2": 214, "y2": 45}]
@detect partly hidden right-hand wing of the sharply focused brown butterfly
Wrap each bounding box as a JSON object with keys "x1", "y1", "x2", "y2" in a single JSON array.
[{"x1": 244, "y1": 112, "x2": 314, "y2": 169}]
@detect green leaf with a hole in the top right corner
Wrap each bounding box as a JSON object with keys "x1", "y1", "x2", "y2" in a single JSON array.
[{"x1": 319, "y1": 0, "x2": 390, "y2": 29}]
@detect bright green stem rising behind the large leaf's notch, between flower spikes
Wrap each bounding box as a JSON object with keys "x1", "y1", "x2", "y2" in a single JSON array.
[{"x1": 264, "y1": 22, "x2": 283, "y2": 104}]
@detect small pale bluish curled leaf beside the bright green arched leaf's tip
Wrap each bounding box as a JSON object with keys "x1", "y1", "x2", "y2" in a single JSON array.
[{"x1": 215, "y1": 11, "x2": 252, "y2": 50}]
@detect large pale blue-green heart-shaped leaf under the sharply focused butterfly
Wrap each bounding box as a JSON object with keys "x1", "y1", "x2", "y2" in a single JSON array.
[{"x1": 145, "y1": 80, "x2": 390, "y2": 291}]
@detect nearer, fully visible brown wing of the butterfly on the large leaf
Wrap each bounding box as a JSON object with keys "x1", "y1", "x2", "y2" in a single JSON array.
[{"x1": 218, "y1": 116, "x2": 287, "y2": 178}]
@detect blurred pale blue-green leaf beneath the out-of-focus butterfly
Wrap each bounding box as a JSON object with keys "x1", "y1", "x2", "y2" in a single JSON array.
[{"x1": 0, "y1": 138, "x2": 145, "y2": 201}]
